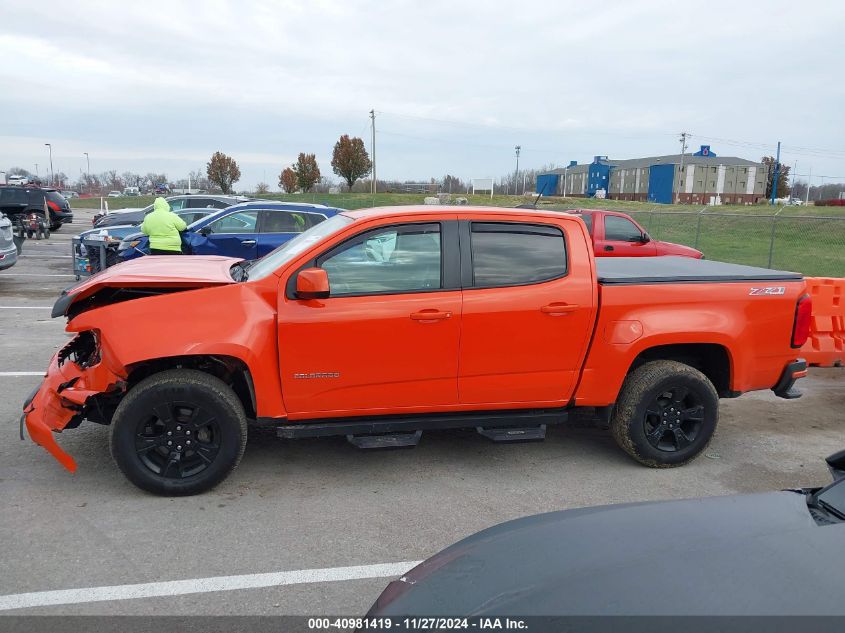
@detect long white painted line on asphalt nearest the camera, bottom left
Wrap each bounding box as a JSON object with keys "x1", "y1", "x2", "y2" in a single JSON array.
[{"x1": 0, "y1": 561, "x2": 420, "y2": 611}]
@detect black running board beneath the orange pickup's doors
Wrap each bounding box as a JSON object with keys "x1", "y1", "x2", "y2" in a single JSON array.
[{"x1": 276, "y1": 408, "x2": 569, "y2": 441}]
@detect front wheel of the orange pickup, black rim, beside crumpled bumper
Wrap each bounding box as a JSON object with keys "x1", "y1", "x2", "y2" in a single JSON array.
[{"x1": 111, "y1": 369, "x2": 247, "y2": 496}]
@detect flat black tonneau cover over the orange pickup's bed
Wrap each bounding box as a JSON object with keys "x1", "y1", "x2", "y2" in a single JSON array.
[{"x1": 596, "y1": 257, "x2": 803, "y2": 286}]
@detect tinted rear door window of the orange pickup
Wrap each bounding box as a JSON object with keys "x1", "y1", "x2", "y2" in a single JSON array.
[{"x1": 471, "y1": 222, "x2": 567, "y2": 287}]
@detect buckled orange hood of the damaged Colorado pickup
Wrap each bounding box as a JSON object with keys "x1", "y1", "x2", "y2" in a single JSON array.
[{"x1": 52, "y1": 255, "x2": 240, "y2": 318}]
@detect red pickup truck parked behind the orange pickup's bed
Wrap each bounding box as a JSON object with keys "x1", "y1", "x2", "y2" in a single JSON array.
[{"x1": 567, "y1": 209, "x2": 702, "y2": 259}]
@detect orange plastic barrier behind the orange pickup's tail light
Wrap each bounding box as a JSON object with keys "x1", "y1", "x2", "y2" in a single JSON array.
[{"x1": 801, "y1": 277, "x2": 845, "y2": 367}]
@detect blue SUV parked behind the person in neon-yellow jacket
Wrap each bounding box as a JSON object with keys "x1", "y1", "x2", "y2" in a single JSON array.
[{"x1": 120, "y1": 201, "x2": 341, "y2": 261}]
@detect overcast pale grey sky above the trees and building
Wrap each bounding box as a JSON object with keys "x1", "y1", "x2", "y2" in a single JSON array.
[{"x1": 0, "y1": 0, "x2": 845, "y2": 189}]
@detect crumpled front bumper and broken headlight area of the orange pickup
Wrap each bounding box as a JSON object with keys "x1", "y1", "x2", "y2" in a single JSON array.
[{"x1": 21, "y1": 330, "x2": 125, "y2": 472}]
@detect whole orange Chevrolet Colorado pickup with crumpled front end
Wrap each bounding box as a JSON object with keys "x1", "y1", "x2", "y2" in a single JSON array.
[{"x1": 21, "y1": 207, "x2": 811, "y2": 495}]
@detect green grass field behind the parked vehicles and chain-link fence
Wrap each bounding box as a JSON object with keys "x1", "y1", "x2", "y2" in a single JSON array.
[{"x1": 71, "y1": 193, "x2": 845, "y2": 277}]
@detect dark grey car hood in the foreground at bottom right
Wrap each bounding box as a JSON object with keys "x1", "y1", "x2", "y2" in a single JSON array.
[{"x1": 370, "y1": 491, "x2": 845, "y2": 616}]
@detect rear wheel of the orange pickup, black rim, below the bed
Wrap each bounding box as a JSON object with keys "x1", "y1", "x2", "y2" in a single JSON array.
[{"x1": 610, "y1": 360, "x2": 719, "y2": 468}]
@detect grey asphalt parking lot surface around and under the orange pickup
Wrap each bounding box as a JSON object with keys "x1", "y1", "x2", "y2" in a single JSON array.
[{"x1": 0, "y1": 210, "x2": 845, "y2": 615}]
